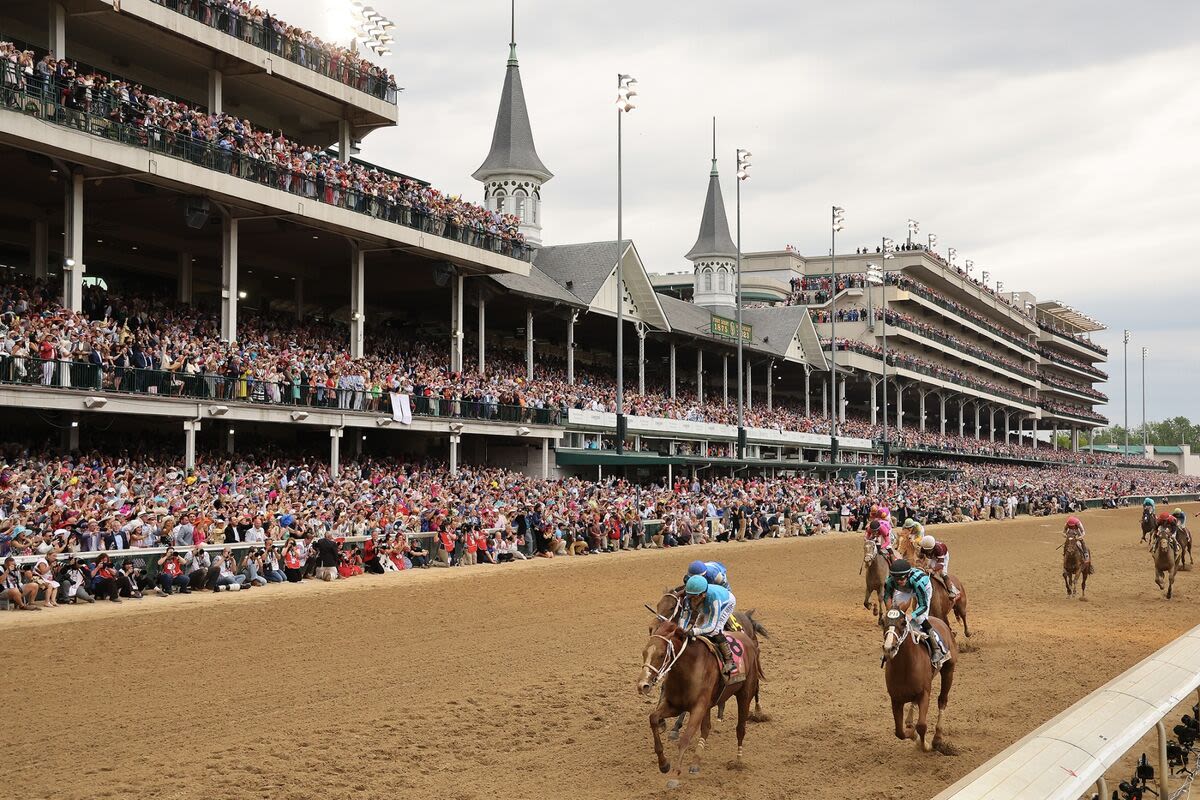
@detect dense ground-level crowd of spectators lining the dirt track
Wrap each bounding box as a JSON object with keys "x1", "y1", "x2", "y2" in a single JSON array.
[{"x1": 0, "y1": 445, "x2": 1198, "y2": 607}]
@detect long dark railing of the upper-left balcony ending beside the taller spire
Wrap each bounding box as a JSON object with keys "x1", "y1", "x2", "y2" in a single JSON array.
[{"x1": 0, "y1": 86, "x2": 530, "y2": 261}]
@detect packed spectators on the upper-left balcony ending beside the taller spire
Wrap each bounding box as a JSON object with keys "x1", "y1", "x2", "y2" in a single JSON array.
[{"x1": 0, "y1": 42, "x2": 527, "y2": 258}]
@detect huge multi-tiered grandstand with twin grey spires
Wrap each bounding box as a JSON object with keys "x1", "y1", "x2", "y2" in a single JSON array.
[{"x1": 0, "y1": 0, "x2": 1118, "y2": 476}]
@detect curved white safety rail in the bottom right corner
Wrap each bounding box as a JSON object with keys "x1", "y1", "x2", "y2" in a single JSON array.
[{"x1": 934, "y1": 626, "x2": 1200, "y2": 800}]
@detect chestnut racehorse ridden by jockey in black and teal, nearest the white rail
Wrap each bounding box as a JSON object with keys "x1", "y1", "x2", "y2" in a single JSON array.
[{"x1": 883, "y1": 608, "x2": 959, "y2": 752}]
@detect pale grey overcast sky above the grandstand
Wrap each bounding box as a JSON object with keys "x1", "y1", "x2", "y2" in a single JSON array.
[{"x1": 274, "y1": 0, "x2": 1200, "y2": 423}]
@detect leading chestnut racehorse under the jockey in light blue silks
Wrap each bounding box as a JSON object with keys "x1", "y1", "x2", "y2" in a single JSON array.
[{"x1": 637, "y1": 620, "x2": 762, "y2": 777}]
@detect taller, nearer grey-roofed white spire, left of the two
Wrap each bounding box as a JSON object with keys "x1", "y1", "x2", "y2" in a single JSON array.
[{"x1": 472, "y1": 0, "x2": 554, "y2": 246}]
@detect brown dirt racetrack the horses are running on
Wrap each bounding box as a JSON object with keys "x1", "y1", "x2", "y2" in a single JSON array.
[{"x1": 7, "y1": 505, "x2": 1200, "y2": 800}]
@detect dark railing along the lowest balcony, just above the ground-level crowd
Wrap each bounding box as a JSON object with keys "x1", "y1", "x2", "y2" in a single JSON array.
[{"x1": 0, "y1": 355, "x2": 563, "y2": 426}]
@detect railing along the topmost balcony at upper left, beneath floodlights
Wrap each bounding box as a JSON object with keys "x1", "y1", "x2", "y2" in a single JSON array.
[{"x1": 151, "y1": 0, "x2": 397, "y2": 106}]
